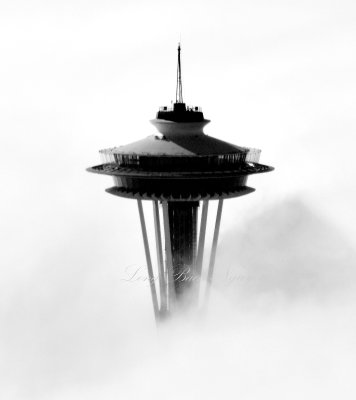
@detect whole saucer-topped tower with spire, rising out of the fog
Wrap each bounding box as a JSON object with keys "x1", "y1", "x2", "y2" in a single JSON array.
[{"x1": 88, "y1": 45, "x2": 273, "y2": 320}]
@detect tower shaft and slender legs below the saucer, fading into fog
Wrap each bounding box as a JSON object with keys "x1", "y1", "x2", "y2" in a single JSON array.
[{"x1": 137, "y1": 199, "x2": 223, "y2": 321}]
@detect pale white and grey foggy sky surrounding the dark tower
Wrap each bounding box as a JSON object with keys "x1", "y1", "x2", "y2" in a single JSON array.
[{"x1": 0, "y1": 0, "x2": 356, "y2": 400}]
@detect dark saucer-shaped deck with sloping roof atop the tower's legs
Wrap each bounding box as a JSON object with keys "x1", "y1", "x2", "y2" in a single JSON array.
[{"x1": 88, "y1": 126, "x2": 273, "y2": 201}]
